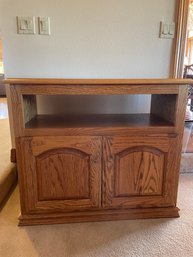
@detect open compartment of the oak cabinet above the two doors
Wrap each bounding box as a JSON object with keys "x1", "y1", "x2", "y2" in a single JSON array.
[{"x1": 22, "y1": 94, "x2": 177, "y2": 129}]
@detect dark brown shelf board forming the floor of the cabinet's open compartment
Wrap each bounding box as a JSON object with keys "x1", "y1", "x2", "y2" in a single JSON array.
[{"x1": 25, "y1": 114, "x2": 174, "y2": 129}]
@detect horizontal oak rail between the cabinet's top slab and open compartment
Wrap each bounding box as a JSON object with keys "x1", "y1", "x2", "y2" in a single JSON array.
[{"x1": 11, "y1": 84, "x2": 181, "y2": 95}]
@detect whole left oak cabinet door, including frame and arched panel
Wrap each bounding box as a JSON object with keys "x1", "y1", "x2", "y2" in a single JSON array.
[{"x1": 17, "y1": 136, "x2": 102, "y2": 213}]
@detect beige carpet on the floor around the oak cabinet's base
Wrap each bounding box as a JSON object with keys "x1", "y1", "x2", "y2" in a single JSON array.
[{"x1": 0, "y1": 174, "x2": 193, "y2": 257}]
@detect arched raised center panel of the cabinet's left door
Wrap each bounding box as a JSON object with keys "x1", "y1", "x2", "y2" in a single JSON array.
[{"x1": 36, "y1": 148, "x2": 90, "y2": 201}]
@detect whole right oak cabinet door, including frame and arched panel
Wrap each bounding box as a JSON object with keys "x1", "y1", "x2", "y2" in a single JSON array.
[{"x1": 102, "y1": 135, "x2": 178, "y2": 208}]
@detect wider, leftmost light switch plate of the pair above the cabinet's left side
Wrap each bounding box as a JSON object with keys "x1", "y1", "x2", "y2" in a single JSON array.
[{"x1": 17, "y1": 16, "x2": 35, "y2": 34}]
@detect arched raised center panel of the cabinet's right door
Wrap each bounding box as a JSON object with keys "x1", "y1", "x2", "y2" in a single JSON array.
[{"x1": 114, "y1": 146, "x2": 164, "y2": 197}]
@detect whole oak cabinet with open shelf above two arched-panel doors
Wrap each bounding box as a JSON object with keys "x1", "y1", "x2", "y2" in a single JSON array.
[{"x1": 5, "y1": 79, "x2": 192, "y2": 225}]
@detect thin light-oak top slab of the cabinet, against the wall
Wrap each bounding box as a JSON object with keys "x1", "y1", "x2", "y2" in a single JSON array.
[{"x1": 3, "y1": 78, "x2": 193, "y2": 85}]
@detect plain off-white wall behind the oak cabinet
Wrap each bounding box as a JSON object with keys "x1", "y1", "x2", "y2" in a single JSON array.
[{"x1": 0, "y1": 0, "x2": 176, "y2": 144}]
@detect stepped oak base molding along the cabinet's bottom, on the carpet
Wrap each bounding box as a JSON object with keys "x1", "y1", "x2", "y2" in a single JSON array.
[{"x1": 19, "y1": 207, "x2": 179, "y2": 226}]
